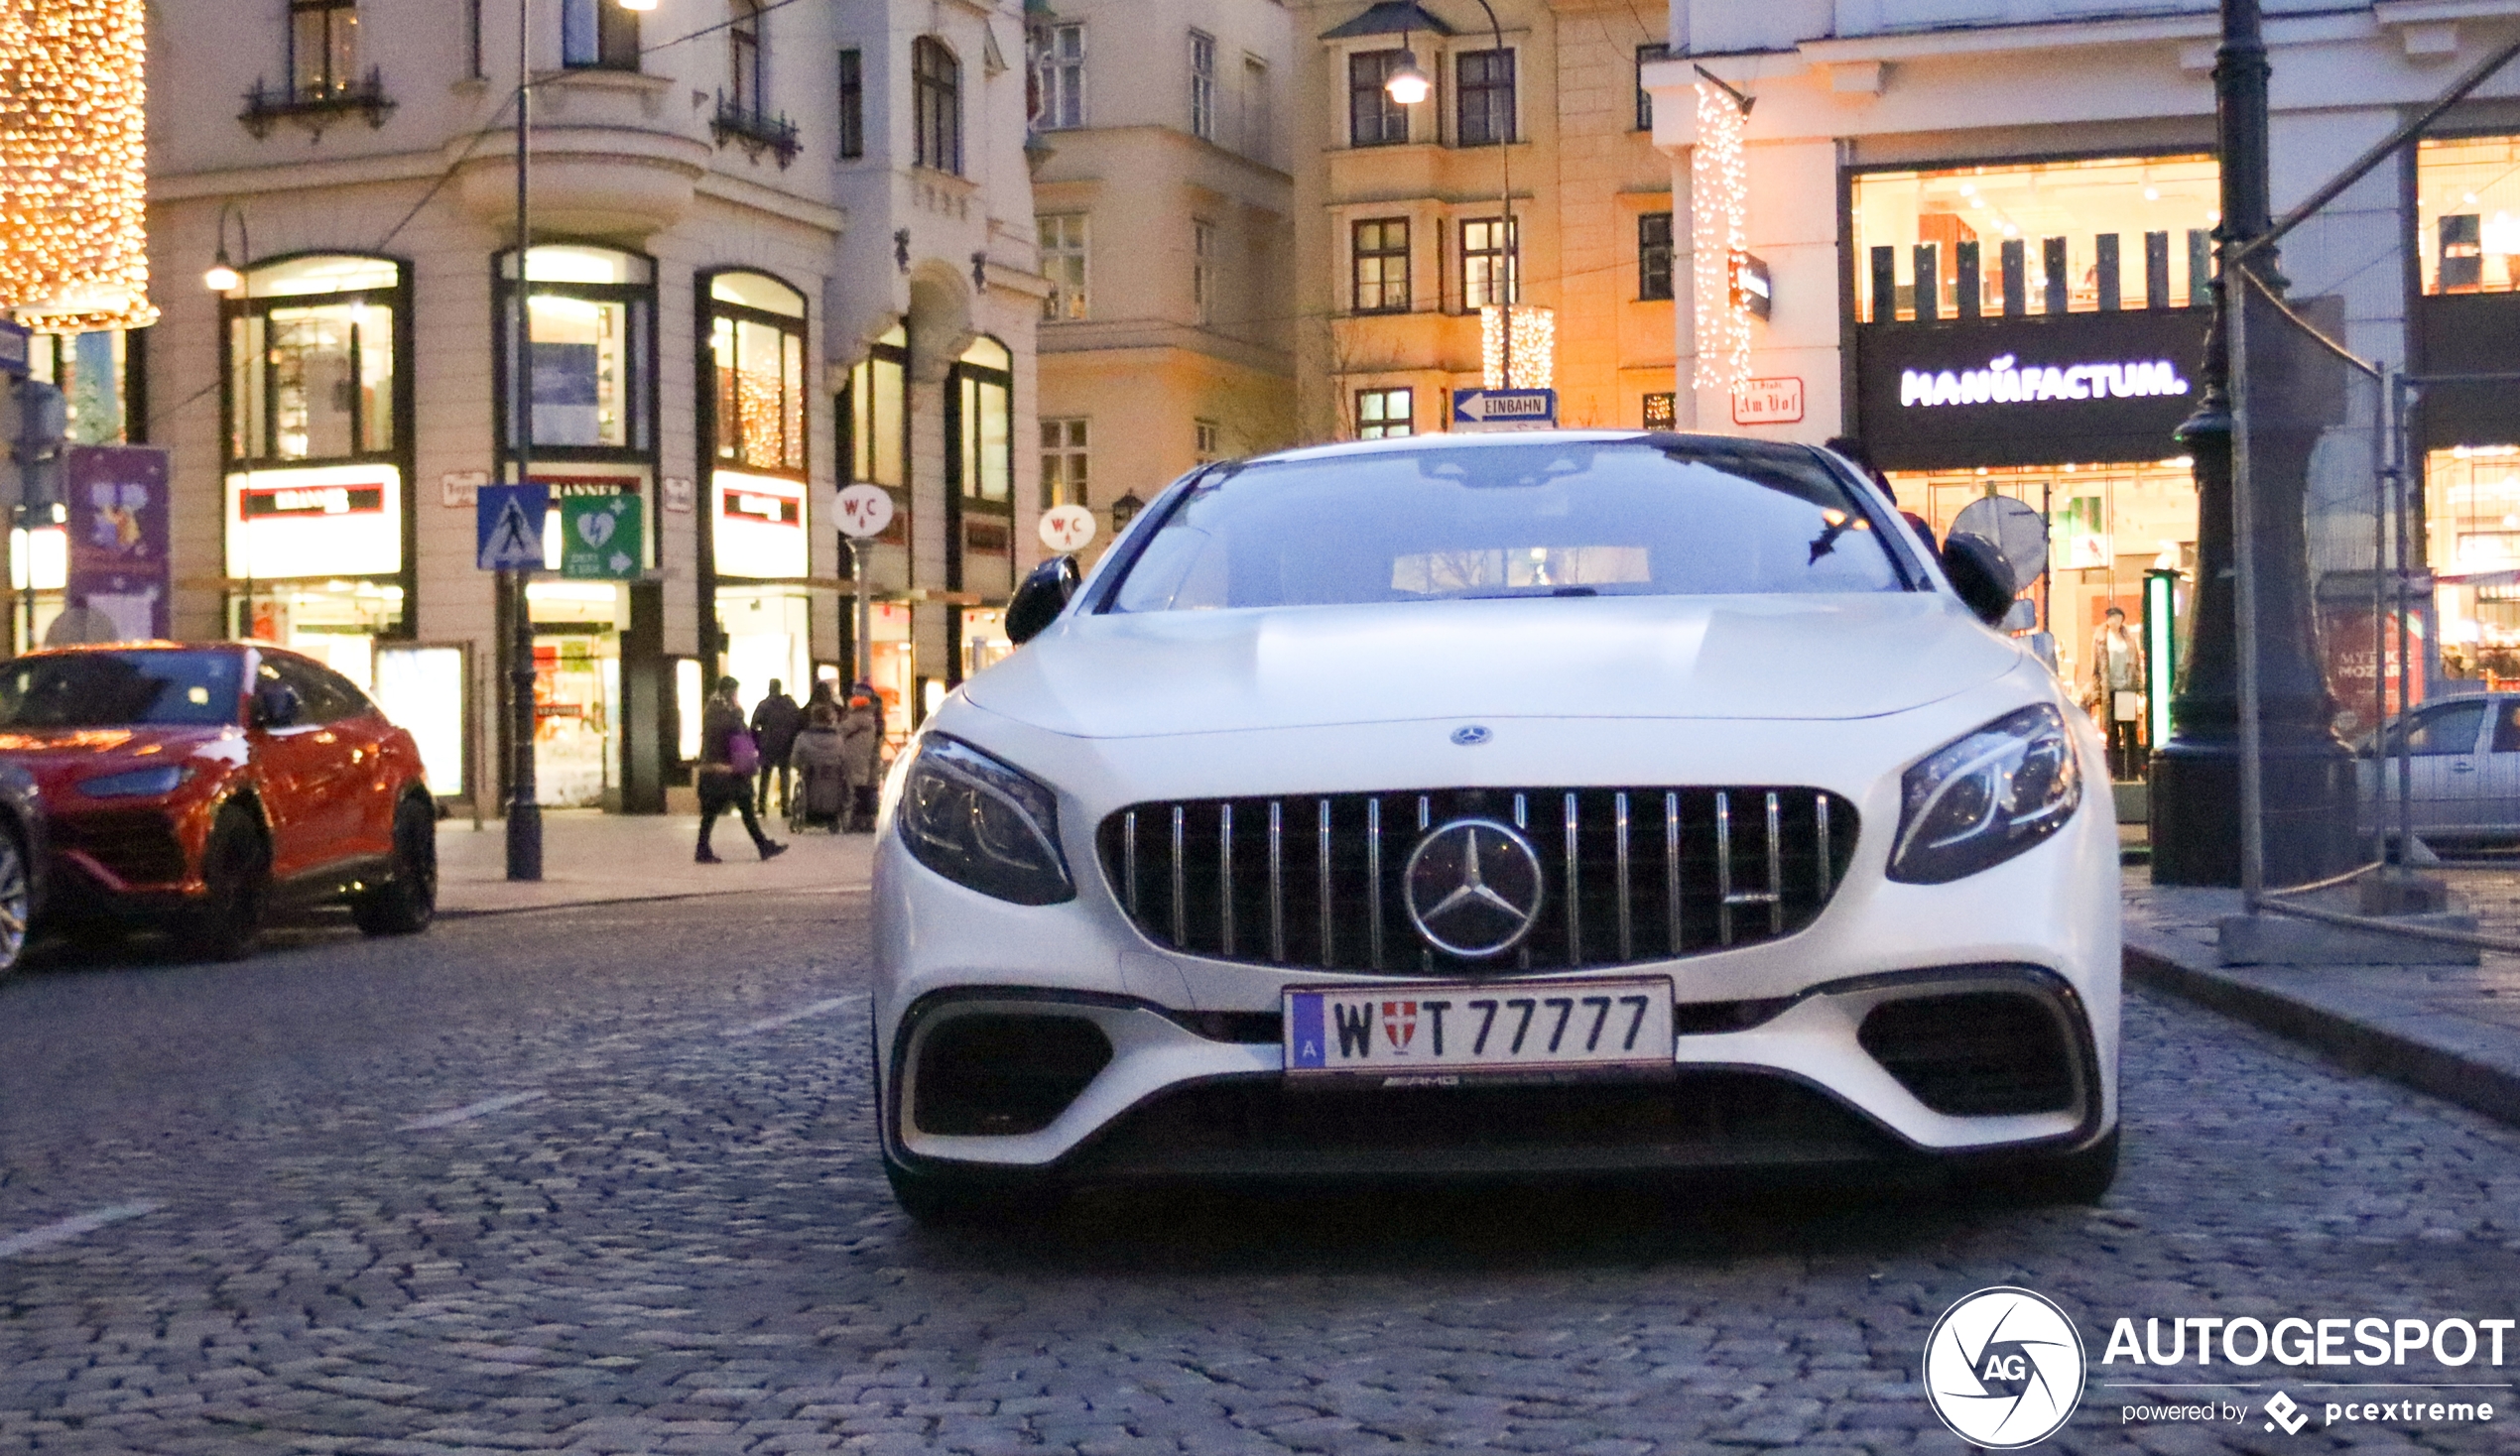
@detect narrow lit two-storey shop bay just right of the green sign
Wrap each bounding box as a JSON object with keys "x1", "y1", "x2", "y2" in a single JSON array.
[{"x1": 703, "y1": 272, "x2": 814, "y2": 703}]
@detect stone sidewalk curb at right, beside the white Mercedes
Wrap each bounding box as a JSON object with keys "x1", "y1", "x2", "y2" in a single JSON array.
[{"x1": 2124, "y1": 924, "x2": 2520, "y2": 1126}]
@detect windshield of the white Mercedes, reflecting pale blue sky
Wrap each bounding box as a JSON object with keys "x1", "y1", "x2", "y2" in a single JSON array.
[{"x1": 1104, "y1": 440, "x2": 1905, "y2": 612}]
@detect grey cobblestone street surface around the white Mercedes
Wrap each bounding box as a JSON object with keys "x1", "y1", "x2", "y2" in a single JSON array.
[{"x1": 0, "y1": 890, "x2": 2520, "y2": 1456}]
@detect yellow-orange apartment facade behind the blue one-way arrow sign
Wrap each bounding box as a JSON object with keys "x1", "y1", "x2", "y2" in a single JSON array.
[{"x1": 1296, "y1": 0, "x2": 1674, "y2": 438}]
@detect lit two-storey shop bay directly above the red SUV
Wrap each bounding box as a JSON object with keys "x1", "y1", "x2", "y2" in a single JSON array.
[{"x1": 219, "y1": 255, "x2": 416, "y2": 690}]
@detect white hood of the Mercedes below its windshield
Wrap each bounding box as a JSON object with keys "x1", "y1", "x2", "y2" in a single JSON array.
[{"x1": 965, "y1": 592, "x2": 2024, "y2": 738}]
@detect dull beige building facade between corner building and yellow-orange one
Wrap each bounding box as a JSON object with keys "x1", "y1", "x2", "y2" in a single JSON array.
[{"x1": 1031, "y1": 0, "x2": 1296, "y2": 544}]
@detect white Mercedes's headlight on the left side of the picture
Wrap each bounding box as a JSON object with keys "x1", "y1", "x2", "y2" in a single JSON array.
[{"x1": 892, "y1": 733, "x2": 1076, "y2": 905}]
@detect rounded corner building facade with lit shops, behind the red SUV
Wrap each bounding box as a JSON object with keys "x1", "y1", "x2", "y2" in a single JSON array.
[{"x1": 135, "y1": 0, "x2": 1044, "y2": 811}]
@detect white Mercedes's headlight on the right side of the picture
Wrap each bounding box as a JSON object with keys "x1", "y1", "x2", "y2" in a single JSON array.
[{"x1": 1890, "y1": 705, "x2": 2081, "y2": 884}]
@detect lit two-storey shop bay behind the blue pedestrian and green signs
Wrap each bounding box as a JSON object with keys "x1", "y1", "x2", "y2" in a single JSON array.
[{"x1": 494, "y1": 244, "x2": 676, "y2": 811}]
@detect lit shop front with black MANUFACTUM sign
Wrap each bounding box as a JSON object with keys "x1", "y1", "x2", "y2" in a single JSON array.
[{"x1": 1847, "y1": 156, "x2": 2217, "y2": 710}]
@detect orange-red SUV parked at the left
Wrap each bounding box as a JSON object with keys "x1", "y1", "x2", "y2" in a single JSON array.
[{"x1": 0, "y1": 643, "x2": 439, "y2": 960}]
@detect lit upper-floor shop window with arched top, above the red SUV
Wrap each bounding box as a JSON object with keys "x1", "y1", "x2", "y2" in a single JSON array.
[{"x1": 219, "y1": 255, "x2": 403, "y2": 466}]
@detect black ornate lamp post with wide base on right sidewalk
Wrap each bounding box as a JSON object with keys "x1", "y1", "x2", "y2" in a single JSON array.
[{"x1": 2152, "y1": 0, "x2": 2353, "y2": 887}]
